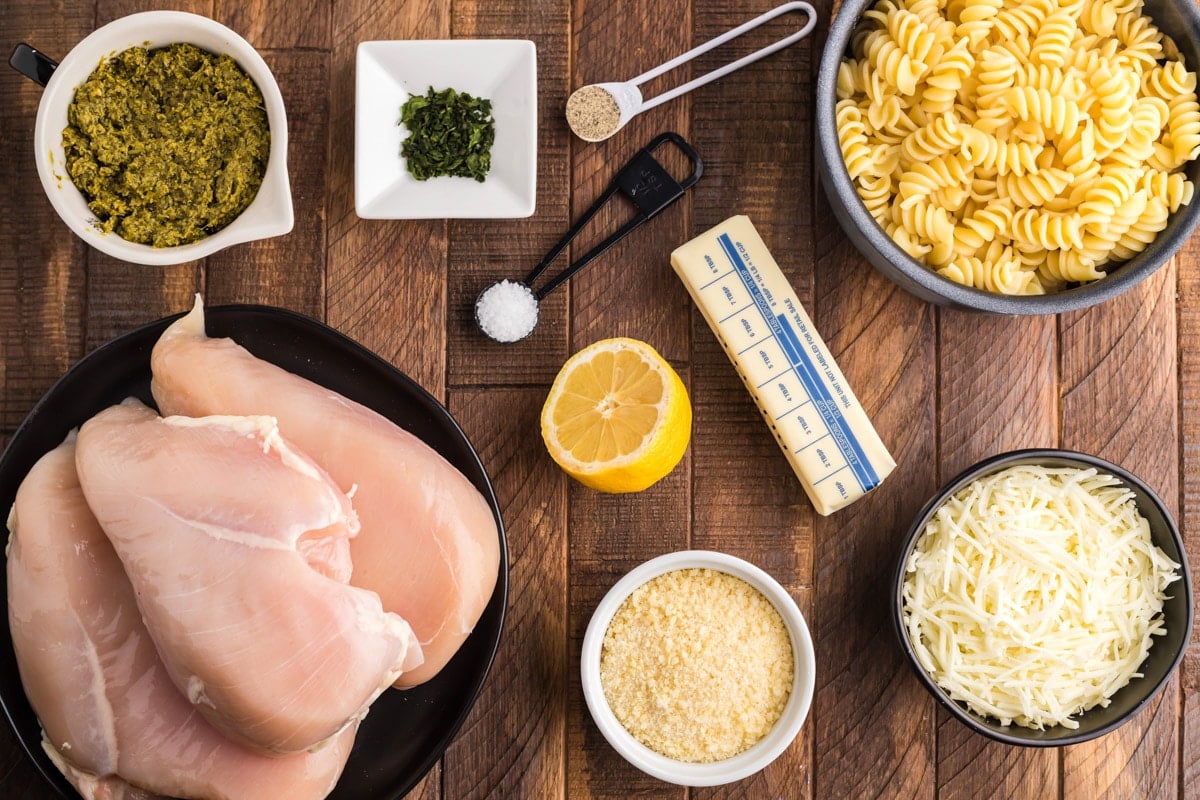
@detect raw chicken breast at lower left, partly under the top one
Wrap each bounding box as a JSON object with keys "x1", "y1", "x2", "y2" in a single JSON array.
[{"x1": 7, "y1": 440, "x2": 354, "y2": 800}]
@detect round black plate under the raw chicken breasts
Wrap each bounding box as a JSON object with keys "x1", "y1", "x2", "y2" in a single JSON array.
[{"x1": 0, "y1": 306, "x2": 508, "y2": 800}]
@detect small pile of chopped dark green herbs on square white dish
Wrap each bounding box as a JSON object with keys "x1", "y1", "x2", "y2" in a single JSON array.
[{"x1": 400, "y1": 86, "x2": 496, "y2": 181}]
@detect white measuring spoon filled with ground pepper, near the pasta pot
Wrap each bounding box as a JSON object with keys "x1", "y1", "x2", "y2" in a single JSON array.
[{"x1": 566, "y1": 2, "x2": 817, "y2": 142}]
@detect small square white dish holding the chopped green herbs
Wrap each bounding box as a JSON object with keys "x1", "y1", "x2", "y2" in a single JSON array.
[{"x1": 354, "y1": 40, "x2": 538, "y2": 219}]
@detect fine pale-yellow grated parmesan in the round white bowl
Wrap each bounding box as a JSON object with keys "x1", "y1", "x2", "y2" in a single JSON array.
[{"x1": 600, "y1": 569, "x2": 794, "y2": 763}]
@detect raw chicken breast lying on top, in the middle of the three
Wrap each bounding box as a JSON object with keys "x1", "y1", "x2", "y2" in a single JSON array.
[{"x1": 76, "y1": 401, "x2": 420, "y2": 753}]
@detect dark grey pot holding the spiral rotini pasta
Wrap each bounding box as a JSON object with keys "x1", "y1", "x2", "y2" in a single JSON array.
[{"x1": 816, "y1": 0, "x2": 1200, "y2": 314}]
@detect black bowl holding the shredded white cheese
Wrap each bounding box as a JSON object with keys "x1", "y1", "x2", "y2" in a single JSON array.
[{"x1": 892, "y1": 450, "x2": 1193, "y2": 747}]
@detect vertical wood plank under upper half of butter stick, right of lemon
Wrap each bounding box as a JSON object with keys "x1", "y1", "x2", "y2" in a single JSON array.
[{"x1": 691, "y1": 0, "x2": 815, "y2": 800}]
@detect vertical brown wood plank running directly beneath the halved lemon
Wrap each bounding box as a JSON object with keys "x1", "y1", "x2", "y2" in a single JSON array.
[{"x1": 562, "y1": 0, "x2": 694, "y2": 799}]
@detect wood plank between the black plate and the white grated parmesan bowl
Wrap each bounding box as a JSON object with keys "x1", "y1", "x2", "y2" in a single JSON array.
[{"x1": 443, "y1": 389, "x2": 569, "y2": 800}]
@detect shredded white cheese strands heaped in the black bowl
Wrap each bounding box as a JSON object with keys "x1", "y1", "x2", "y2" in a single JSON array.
[{"x1": 902, "y1": 464, "x2": 1180, "y2": 729}]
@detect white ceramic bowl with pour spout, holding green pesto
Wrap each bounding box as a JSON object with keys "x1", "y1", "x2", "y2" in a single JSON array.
[{"x1": 34, "y1": 11, "x2": 293, "y2": 264}]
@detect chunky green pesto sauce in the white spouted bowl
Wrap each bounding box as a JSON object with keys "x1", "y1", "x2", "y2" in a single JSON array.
[{"x1": 62, "y1": 44, "x2": 271, "y2": 247}]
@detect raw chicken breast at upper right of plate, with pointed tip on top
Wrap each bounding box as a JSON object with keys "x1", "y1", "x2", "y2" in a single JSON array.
[{"x1": 150, "y1": 297, "x2": 500, "y2": 687}]
